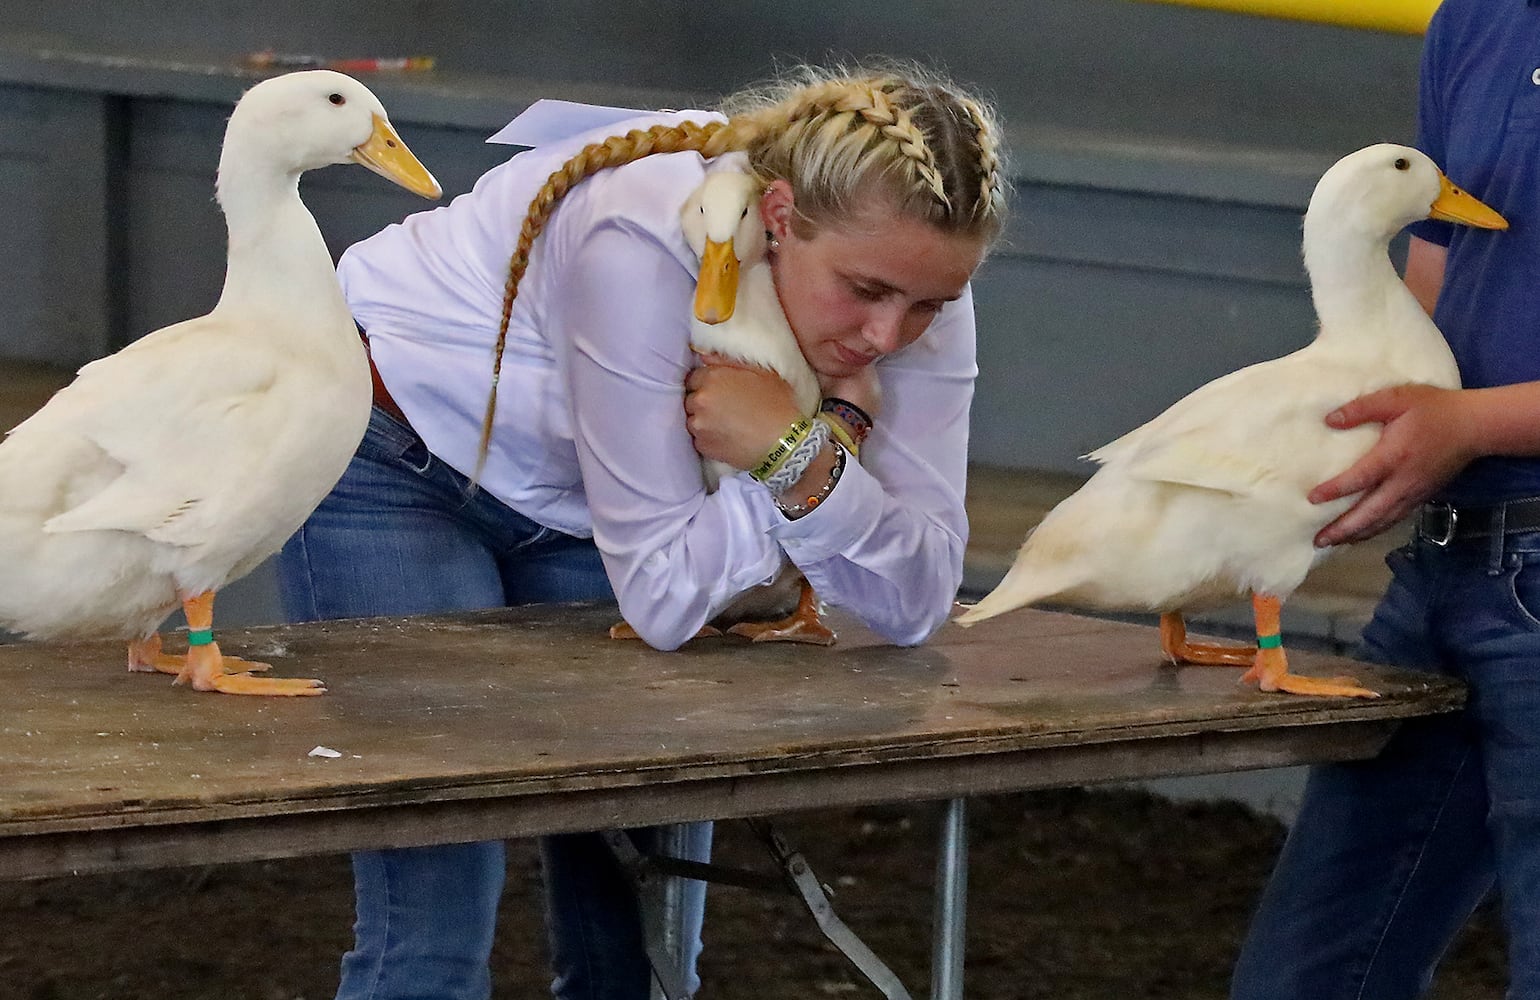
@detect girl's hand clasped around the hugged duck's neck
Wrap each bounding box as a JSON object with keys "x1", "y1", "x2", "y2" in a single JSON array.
[{"x1": 684, "y1": 354, "x2": 802, "y2": 468}]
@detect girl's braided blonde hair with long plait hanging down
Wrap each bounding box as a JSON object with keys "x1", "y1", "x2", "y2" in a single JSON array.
[{"x1": 471, "y1": 65, "x2": 1006, "y2": 474}]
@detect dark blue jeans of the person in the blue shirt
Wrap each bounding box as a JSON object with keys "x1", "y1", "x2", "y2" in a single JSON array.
[{"x1": 1230, "y1": 532, "x2": 1540, "y2": 1000}]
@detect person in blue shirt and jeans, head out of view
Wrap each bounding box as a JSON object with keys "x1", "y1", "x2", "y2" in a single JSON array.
[{"x1": 1232, "y1": 0, "x2": 1540, "y2": 1000}]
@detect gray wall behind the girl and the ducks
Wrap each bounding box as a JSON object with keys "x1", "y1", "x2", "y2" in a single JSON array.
[{"x1": 0, "y1": 0, "x2": 1420, "y2": 470}]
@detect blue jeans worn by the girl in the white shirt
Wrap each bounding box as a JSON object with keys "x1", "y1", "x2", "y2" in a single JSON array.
[{"x1": 279, "y1": 408, "x2": 711, "y2": 1000}]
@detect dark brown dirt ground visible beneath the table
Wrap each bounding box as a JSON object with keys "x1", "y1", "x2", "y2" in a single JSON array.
[{"x1": 0, "y1": 789, "x2": 1503, "y2": 1000}]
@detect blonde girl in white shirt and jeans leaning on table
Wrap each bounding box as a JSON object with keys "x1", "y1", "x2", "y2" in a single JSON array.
[{"x1": 280, "y1": 66, "x2": 1004, "y2": 1000}]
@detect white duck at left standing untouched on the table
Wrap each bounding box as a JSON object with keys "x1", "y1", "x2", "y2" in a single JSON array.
[{"x1": 0, "y1": 71, "x2": 440, "y2": 695}]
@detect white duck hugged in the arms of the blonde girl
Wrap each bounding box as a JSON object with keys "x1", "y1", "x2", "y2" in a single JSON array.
[{"x1": 610, "y1": 156, "x2": 835, "y2": 646}]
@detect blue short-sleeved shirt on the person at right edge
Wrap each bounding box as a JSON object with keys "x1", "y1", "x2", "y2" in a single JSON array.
[{"x1": 1411, "y1": 0, "x2": 1540, "y2": 504}]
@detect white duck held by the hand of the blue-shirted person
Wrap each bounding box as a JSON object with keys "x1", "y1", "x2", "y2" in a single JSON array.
[{"x1": 958, "y1": 143, "x2": 1508, "y2": 696}]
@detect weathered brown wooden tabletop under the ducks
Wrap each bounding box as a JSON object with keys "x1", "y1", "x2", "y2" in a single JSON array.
[{"x1": 0, "y1": 606, "x2": 1463, "y2": 877}]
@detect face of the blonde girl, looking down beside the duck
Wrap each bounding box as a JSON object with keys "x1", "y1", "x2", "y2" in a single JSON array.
[{"x1": 759, "y1": 180, "x2": 984, "y2": 379}]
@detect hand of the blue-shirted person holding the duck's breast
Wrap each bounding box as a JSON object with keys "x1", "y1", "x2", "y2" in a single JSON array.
[{"x1": 1309, "y1": 385, "x2": 1477, "y2": 547}]
